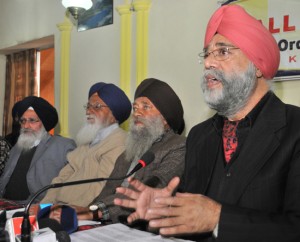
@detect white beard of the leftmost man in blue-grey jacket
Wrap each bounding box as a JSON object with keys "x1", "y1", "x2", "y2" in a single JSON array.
[{"x1": 17, "y1": 126, "x2": 47, "y2": 150}]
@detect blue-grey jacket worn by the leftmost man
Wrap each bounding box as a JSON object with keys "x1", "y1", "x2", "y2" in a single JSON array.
[{"x1": 0, "y1": 134, "x2": 76, "y2": 203}]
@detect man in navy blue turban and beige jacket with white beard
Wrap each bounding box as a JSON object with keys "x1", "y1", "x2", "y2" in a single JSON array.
[{"x1": 41, "y1": 82, "x2": 131, "y2": 206}]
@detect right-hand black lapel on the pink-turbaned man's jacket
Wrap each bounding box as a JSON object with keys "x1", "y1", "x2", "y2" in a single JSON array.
[{"x1": 223, "y1": 95, "x2": 286, "y2": 204}]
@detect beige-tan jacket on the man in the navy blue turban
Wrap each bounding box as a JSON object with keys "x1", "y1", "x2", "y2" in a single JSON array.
[{"x1": 41, "y1": 128, "x2": 126, "y2": 207}]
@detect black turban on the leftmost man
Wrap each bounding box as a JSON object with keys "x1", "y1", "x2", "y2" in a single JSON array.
[{"x1": 18, "y1": 96, "x2": 58, "y2": 131}]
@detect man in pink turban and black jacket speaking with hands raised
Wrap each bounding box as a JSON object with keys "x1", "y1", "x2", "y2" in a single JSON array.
[{"x1": 115, "y1": 5, "x2": 300, "y2": 242}]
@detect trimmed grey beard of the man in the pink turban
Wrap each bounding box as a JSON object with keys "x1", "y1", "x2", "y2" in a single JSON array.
[{"x1": 201, "y1": 63, "x2": 257, "y2": 117}]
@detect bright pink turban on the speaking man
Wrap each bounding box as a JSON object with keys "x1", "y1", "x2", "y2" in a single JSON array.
[{"x1": 204, "y1": 5, "x2": 280, "y2": 79}]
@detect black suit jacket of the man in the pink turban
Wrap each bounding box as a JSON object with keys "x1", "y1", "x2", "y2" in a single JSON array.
[{"x1": 182, "y1": 93, "x2": 300, "y2": 242}]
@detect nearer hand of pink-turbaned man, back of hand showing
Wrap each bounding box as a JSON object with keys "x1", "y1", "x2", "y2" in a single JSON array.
[{"x1": 146, "y1": 193, "x2": 221, "y2": 235}]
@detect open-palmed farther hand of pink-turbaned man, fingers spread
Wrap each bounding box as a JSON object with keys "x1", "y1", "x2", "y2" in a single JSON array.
[{"x1": 114, "y1": 177, "x2": 179, "y2": 223}]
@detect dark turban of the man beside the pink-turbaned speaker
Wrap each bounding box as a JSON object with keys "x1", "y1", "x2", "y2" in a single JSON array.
[{"x1": 134, "y1": 78, "x2": 185, "y2": 134}]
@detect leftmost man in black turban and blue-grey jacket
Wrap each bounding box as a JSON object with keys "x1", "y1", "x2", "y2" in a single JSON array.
[{"x1": 0, "y1": 96, "x2": 76, "y2": 203}]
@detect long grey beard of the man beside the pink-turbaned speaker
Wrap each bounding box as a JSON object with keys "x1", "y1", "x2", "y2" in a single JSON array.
[{"x1": 125, "y1": 116, "x2": 165, "y2": 161}]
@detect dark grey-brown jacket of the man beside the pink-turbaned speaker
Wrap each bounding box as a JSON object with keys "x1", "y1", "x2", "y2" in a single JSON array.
[{"x1": 92, "y1": 131, "x2": 186, "y2": 222}]
